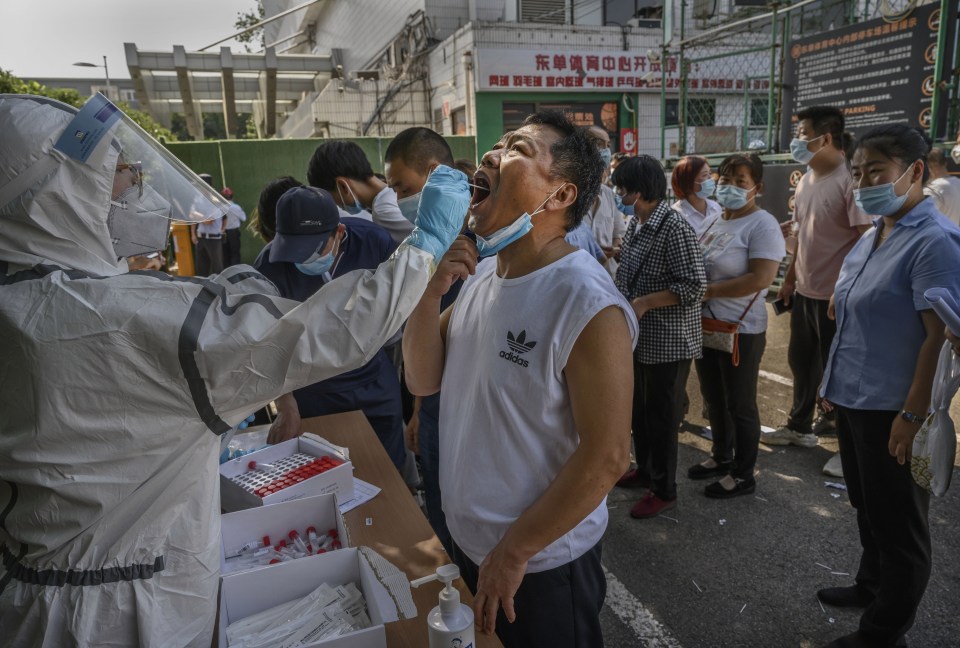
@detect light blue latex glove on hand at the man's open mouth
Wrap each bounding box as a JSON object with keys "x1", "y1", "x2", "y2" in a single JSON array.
[{"x1": 407, "y1": 165, "x2": 470, "y2": 261}]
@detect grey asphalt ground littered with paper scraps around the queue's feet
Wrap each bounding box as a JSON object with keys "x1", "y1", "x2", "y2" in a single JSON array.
[{"x1": 602, "y1": 306, "x2": 960, "y2": 648}]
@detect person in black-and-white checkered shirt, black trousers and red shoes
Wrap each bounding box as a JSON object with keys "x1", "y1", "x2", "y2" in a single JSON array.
[{"x1": 613, "y1": 155, "x2": 707, "y2": 518}]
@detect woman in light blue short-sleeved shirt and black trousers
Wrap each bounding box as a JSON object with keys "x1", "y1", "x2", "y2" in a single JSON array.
[{"x1": 817, "y1": 125, "x2": 960, "y2": 647}]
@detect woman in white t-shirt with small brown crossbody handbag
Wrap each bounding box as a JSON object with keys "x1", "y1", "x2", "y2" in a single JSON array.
[{"x1": 687, "y1": 155, "x2": 786, "y2": 499}]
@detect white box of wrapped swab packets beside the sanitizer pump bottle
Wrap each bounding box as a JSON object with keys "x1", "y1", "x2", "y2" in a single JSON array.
[{"x1": 218, "y1": 548, "x2": 416, "y2": 648}]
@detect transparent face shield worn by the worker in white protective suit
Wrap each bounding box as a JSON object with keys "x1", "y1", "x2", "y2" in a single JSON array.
[{"x1": 56, "y1": 94, "x2": 229, "y2": 257}]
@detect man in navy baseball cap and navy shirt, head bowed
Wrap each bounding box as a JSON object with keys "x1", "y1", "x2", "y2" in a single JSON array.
[{"x1": 254, "y1": 187, "x2": 406, "y2": 471}]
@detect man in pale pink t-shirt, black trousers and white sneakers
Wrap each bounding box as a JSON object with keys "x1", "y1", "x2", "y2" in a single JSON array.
[{"x1": 760, "y1": 106, "x2": 870, "y2": 460}]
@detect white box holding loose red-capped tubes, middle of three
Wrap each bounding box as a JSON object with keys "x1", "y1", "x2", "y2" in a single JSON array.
[{"x1": 220, "y1": 493, "x2": 350, "y2": 574}]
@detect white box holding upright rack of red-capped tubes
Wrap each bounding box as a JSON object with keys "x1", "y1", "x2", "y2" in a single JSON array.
[{"x1": 220, "y1": 436, "x2": 353, "y2": 512}]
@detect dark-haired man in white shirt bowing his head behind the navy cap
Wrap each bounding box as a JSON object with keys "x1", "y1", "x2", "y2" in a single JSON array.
[{"x1": 307, "y1": 140, "x2": 412, "y2": 243}]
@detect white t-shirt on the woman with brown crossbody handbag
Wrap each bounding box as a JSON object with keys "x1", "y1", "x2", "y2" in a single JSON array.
[{"x1": 700, "y1": 209, "x2": 787, "y2": 333}]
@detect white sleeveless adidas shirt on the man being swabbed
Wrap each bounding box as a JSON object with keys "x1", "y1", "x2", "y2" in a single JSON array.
[{"x1": 440, "y1": 250, "x2": 638, "y2": 573}]
